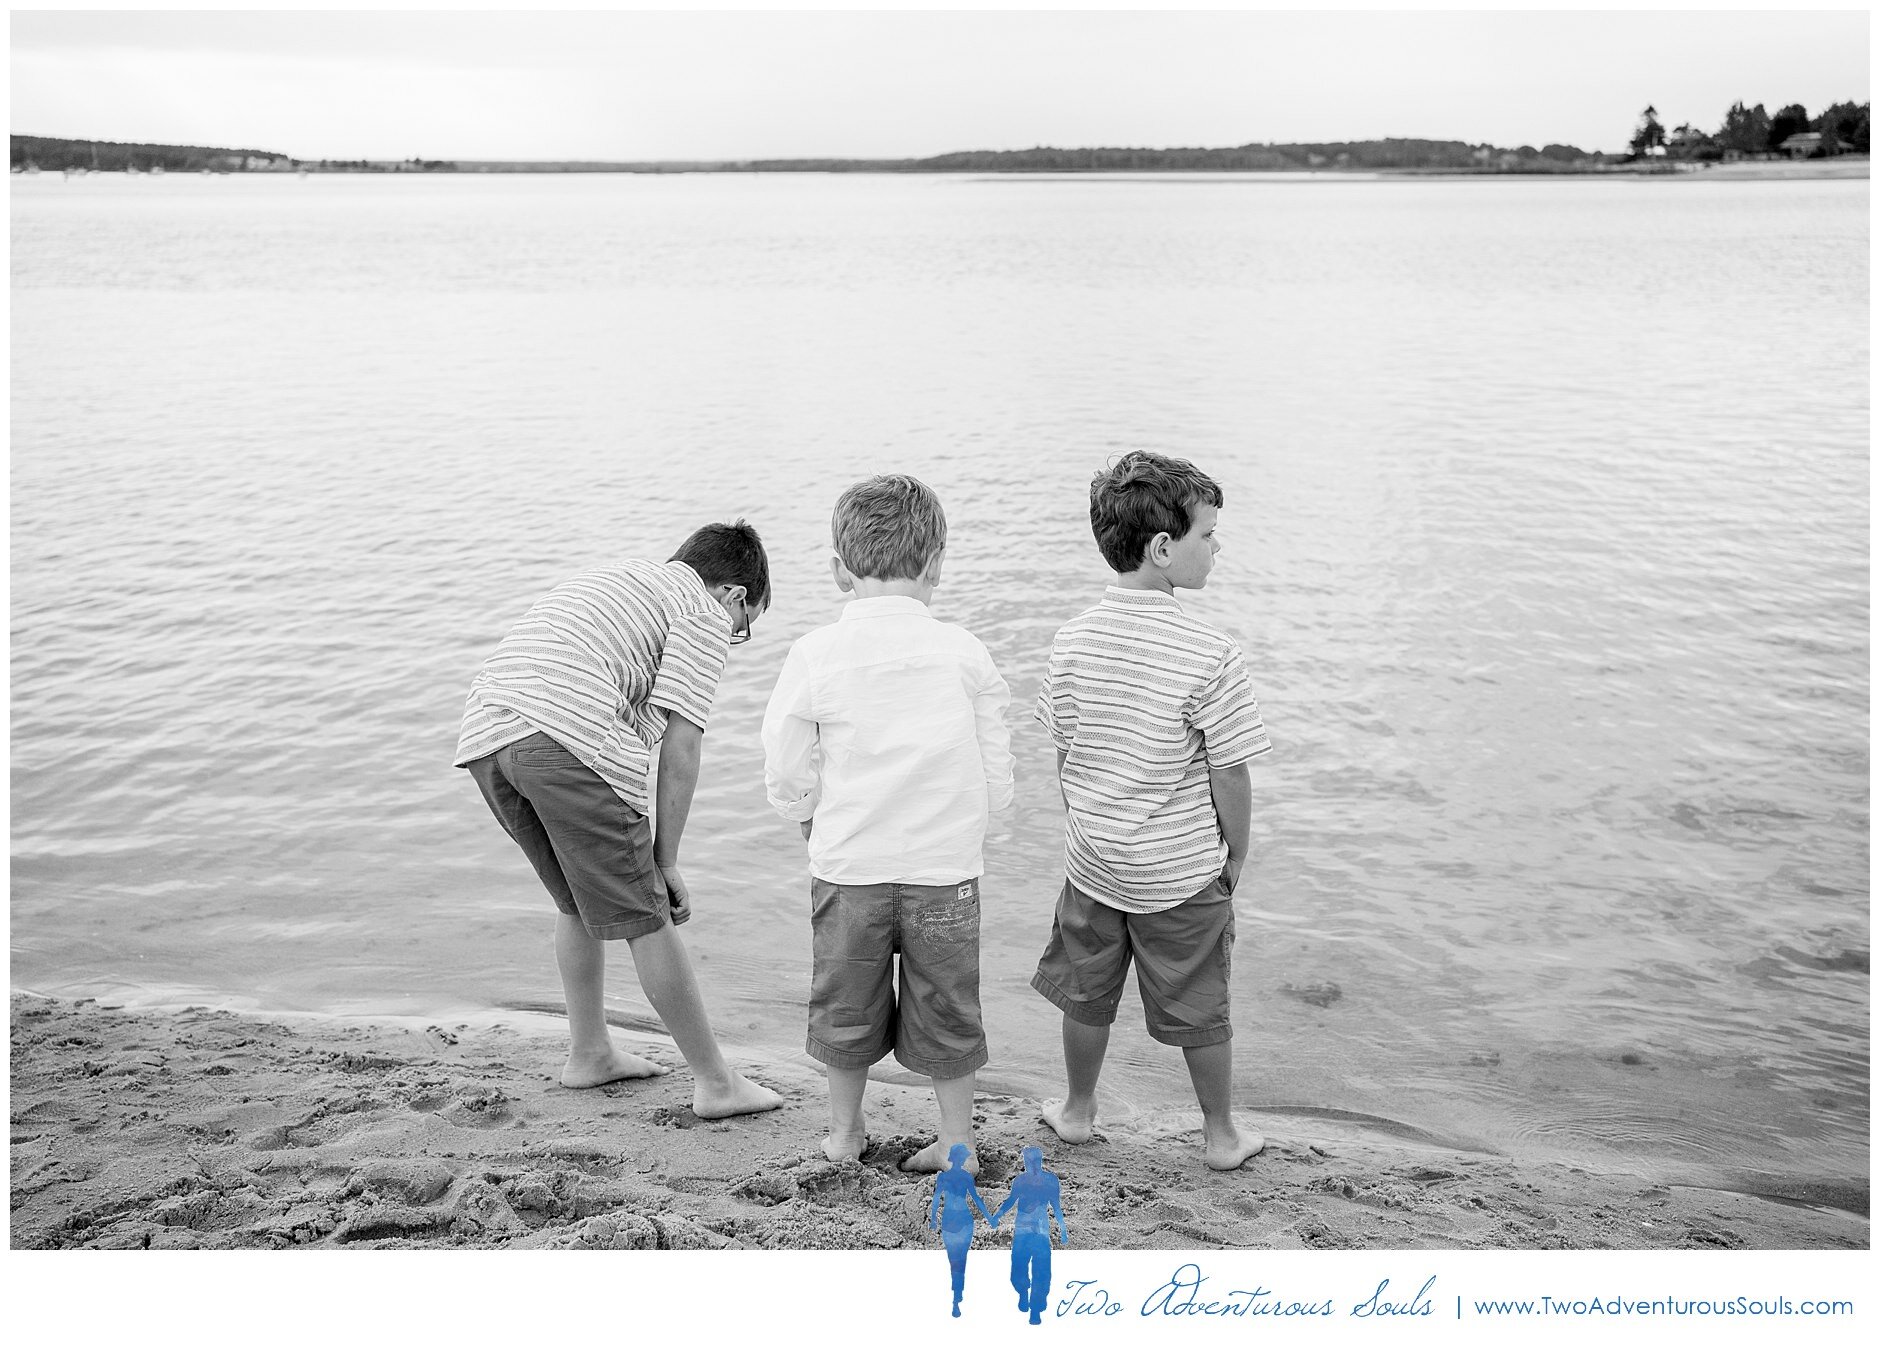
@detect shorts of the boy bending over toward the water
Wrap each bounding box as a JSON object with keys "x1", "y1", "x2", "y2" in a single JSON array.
[{"x1": 468, "y1": 732, "x2": 686, "y2": 941}]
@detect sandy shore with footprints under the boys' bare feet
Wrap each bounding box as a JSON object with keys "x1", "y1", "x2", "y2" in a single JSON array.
[{"x1": 11, "y1": 993, "x2": 1869, "y2": 1249}]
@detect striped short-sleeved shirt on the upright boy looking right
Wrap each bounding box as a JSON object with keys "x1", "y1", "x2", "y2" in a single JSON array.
[{"x1": 1036, "y1": 585, "x2": 1273, "y2": 912}]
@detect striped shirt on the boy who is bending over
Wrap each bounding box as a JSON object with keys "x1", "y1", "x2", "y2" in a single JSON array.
[{"x1": 457, "y1": 559, "x2": 731, "y2": 814}]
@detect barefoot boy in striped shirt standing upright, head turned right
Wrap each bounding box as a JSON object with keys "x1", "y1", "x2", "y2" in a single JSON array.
[{"x1": 1032, "y1": 451, "x2": 1271, "y2": 1170}]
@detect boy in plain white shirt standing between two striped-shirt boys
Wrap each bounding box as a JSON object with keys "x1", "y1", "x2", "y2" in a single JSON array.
[{"x1": 763, "y1": 476, "x2": 1011, "y2": 1174}]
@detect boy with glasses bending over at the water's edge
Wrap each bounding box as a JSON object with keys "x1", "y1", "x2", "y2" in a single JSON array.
[{"x1": 457, "y1": 519, "x2": 782, "y2": 1119}]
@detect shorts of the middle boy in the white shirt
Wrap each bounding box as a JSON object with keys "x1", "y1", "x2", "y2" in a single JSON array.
[{"x1": 807, "y1": 878, "x2": 987, "y2": 1080}]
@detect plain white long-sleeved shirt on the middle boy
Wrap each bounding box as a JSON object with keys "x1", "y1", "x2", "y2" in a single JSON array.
[{"x1": 763, "y1": 594, "x2": 1011, "y2": 886}]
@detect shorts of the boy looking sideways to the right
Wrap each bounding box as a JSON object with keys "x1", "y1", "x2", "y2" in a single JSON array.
[{"x1": 1032, "y1": 875, "x2": 1233, "y2": 1048}]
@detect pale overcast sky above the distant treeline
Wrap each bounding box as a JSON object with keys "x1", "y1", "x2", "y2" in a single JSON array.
[{"x1": 9, "y1": 9, "x2": 1869, "y2": 160}]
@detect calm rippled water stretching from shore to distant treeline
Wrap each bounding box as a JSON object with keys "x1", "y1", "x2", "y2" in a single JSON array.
[{"x1": 11, "y1": 175, "x2": 1869, "y2": 1185}]
